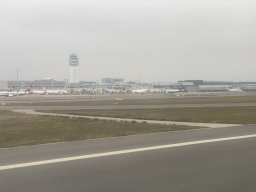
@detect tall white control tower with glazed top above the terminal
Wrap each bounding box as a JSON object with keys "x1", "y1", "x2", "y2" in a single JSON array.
[{"x1": 69, "y1": 53, "x2": 79, "y2": 88}]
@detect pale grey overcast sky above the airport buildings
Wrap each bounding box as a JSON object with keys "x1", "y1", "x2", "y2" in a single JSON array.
[{"x1": 0, "y1": 0, "x2": 256, "y2": 82}]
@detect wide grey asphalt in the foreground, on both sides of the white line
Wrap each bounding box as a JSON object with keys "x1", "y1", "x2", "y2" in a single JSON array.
[{"x1": 0, "y1": 125, "x2": 256, "y2": 192}]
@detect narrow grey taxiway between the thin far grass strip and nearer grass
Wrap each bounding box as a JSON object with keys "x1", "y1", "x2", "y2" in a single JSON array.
[{"x1": 0, "y1": 103, "x2": 256, "y2": 110}]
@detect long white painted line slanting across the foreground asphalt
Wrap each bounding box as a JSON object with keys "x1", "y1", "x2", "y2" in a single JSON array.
[{"x1": 0, "y1": 134, "x2": 256, "y2": 171}]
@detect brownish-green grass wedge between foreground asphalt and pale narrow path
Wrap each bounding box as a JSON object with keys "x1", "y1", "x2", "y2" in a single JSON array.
[{"x1": 0, "y1": 111, "x2": 202, "y2": 148}]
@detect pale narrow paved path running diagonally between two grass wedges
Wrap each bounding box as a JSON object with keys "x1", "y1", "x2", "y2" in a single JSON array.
[{"x1": 12, "y1": 110, "x2": 241, "y2": 128}]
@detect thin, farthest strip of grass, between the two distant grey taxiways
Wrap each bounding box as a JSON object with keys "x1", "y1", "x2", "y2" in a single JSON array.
[{"x1": 6, "y1": 96, "x2": 256, "y2": 106}]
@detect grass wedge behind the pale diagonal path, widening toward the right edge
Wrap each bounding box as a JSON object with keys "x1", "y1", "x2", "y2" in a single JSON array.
[{"x1": 41, "y1": 107, "x2": 256, "y2": 124}]
